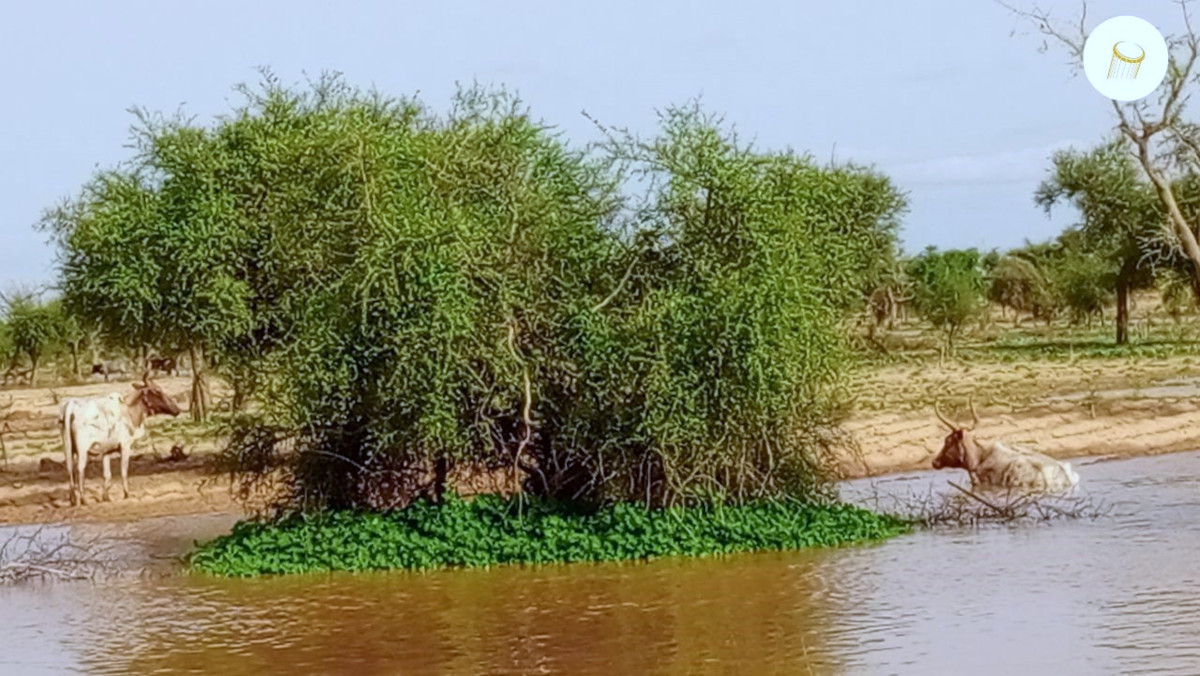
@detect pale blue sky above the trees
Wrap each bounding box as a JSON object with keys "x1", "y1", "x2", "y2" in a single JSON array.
[{"x1": 0, "y1": 0, "x2": 1181, "y2": 289}]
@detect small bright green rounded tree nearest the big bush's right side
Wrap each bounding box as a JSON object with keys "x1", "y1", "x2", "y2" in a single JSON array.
[{"x1": 908, "y1": 247, "x2": 985, "y2": 353}]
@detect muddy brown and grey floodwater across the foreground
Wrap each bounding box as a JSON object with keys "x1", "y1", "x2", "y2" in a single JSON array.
[{"x1": 0, "y1": 453, "x2": 1200, "y2": 676}]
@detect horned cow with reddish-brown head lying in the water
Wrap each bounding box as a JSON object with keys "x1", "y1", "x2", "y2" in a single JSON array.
[{"x1": 934, "y1": 402, "x2": 1079, "y2": 493}]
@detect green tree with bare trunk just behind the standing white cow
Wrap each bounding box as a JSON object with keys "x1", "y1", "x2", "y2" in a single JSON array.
[{"x1": 43, "y1": 121, "x2": 250, "y2": 420}]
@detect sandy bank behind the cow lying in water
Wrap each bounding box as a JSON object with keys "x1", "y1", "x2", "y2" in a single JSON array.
[{"x1": 841, "y1": 357, "x2": 1200, "y2": 477}]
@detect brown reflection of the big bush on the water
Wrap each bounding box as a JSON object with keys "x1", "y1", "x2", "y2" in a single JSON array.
[{"x1": 58, "y1": 552, "x2": 838, "y2": 674}]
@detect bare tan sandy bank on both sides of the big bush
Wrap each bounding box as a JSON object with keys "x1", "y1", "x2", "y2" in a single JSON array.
[{"x1": 7, "y1": 358, "x2": 1200, "y2": 524}]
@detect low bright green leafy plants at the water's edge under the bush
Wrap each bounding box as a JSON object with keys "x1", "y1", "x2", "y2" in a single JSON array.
[{"x1": 190, "y1": 495, "x2": 908, "y2": 576}]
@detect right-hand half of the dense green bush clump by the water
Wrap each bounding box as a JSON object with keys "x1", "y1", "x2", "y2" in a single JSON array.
[{"x1": 529, "y1": 108, "x2": 902, "y2": 504}]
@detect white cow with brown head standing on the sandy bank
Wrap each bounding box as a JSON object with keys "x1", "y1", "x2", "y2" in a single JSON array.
[{"x1": 60, "y1": 379, "x2": 179, "y2": 504}]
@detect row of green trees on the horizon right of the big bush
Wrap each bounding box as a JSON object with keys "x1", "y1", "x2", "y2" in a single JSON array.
[{"x1": 866, "y1": 140, "x2": 1200, "y2": 351}]
